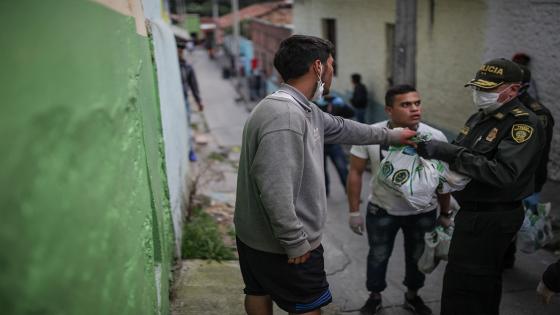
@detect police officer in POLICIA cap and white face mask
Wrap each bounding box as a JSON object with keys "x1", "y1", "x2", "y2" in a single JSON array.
[{"x1": 418, "y1": 59, "x2": 544, "y2": 315}]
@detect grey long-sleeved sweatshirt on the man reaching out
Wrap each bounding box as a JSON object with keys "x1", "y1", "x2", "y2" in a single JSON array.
[{"x1": 234, "y1": 84, "x2": 400, "y2": 257}]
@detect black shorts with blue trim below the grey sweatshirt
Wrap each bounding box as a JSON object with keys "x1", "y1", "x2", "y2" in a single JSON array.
[{"x1": 237, "y1": 239, "x2": 332, "y2": 314}]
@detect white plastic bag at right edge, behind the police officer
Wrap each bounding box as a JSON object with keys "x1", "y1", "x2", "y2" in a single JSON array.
[{"x1": 517, "y1": 202, "x2": 553, "y2": 254}]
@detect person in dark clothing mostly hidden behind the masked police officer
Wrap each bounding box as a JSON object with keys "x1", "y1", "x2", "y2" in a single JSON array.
[{"x1": 504, "y1": 63, "x2": 554, "y2": 269}]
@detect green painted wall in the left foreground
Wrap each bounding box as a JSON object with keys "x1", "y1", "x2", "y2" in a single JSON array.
[{"x1": 0, "y1": 0, "x2": 173, "y2": 315}]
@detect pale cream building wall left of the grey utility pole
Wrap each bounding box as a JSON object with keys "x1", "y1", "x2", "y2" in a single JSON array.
[{"x1": 293, "y1": 0, "x2": 395, "y2": 103}]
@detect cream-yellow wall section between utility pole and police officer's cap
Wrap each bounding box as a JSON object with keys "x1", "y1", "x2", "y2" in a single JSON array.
[{"x1": 416, "y1": 0, "x2": 486, "y2": 134}]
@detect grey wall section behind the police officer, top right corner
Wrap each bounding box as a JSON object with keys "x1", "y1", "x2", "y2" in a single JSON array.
[{"x1": 484, "y1": 0, "x2": 560, "y2": 180}]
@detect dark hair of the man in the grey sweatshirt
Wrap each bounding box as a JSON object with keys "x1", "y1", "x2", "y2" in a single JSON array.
[{"x1": 274, "y1": 35, "x2": 334, "y2": 82}]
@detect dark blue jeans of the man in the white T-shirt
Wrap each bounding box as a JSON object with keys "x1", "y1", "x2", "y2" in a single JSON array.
[{"x1": 366, "y1": 203, "x2": 436, "y2": 293}]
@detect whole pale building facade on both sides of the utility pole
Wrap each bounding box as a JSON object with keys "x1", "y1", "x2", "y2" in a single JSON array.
[{"x1": 294, "y1": 0, "x2": 560, "y2": 180}]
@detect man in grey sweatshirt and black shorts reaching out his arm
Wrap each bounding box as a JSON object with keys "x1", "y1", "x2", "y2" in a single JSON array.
[{"x1": 234, "y1": 35, "x2": 416, "y2": 315}]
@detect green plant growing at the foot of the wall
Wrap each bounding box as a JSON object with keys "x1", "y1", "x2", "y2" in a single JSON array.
[{"x1": 181, "y1": 208, "x2": 235, "y2": 261}]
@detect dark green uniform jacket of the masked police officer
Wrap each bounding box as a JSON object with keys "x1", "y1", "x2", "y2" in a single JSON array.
[{"x1": 451, "y1": 99, "x2": 544, "y2": 205}]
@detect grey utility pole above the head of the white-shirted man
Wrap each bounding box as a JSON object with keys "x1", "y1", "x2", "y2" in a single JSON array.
[{"x1": 392, "y1": 0, "x2": 417, "y2": 86}]
